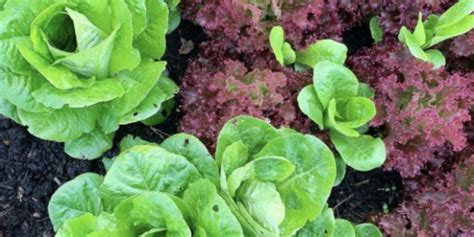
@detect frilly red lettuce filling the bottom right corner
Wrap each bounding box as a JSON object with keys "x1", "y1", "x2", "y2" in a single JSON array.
[{"x1": 379, "y1": 147, "x2": 474, "y2": 237}]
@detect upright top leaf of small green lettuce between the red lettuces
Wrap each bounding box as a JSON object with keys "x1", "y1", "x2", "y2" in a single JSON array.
[{"x1": 313, "y1": 61, "x2": 359, "y2": 109}]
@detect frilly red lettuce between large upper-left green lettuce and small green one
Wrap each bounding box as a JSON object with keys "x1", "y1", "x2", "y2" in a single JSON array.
[{"x1": 179, "y1": 42, "x2": 311, "y2": 149}]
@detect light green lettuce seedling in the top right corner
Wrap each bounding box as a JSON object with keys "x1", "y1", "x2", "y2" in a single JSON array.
[{"x1": 398, "y1": 0, "x2": 474, "y2": 69}]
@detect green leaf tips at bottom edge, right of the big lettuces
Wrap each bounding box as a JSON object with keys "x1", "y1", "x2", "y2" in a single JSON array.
[{"x1": 296, "y1": 205, "x2": 383, "y2": 237}]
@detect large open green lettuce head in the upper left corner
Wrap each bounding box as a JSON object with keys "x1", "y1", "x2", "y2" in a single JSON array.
[{"x1": 0, "y1": 0, "x2": 177, "y2": 159}]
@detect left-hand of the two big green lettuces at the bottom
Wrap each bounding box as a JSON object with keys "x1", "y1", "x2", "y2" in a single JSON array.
[{"x1": 48, "y1": 134, "x2": 243, "y2": 237}]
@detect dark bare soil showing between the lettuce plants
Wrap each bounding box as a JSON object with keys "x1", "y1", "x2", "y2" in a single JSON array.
[{"x1": 0, "y1": 21, "x2": 402, "y2": 237}]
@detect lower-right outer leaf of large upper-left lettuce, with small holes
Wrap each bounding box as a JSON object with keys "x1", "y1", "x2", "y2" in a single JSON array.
[{"x1": 120, "y1": 75, "x2": 179, "y2": 124}]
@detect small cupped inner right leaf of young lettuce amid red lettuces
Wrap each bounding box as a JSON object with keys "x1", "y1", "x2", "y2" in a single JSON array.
[{"x1": 336, "y1": 97, "x2": 376, "y2": 128}]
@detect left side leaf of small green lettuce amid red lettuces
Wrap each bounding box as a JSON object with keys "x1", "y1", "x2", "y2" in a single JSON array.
[{"x1": 297, "y1": 85, "x2": 324, "y2": 130}]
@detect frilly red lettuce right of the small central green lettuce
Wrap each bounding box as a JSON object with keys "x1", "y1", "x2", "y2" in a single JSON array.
[{"x1": 349, "y1": 40, "x2": 474, "y2": 177}]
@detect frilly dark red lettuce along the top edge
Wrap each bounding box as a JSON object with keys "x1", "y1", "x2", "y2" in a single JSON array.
[{"x1": 181, "y1": 0, "x2": 361, "y2": 53}]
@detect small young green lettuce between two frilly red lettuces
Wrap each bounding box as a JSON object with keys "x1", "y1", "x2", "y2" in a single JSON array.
[{"x1": 297, "y1": 53, "x2": 386, "y2": 171}]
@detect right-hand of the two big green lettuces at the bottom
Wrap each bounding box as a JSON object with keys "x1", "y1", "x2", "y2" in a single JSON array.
[{"x1": 216, "y1": 116, "x2": 336, "y2": 236}]
